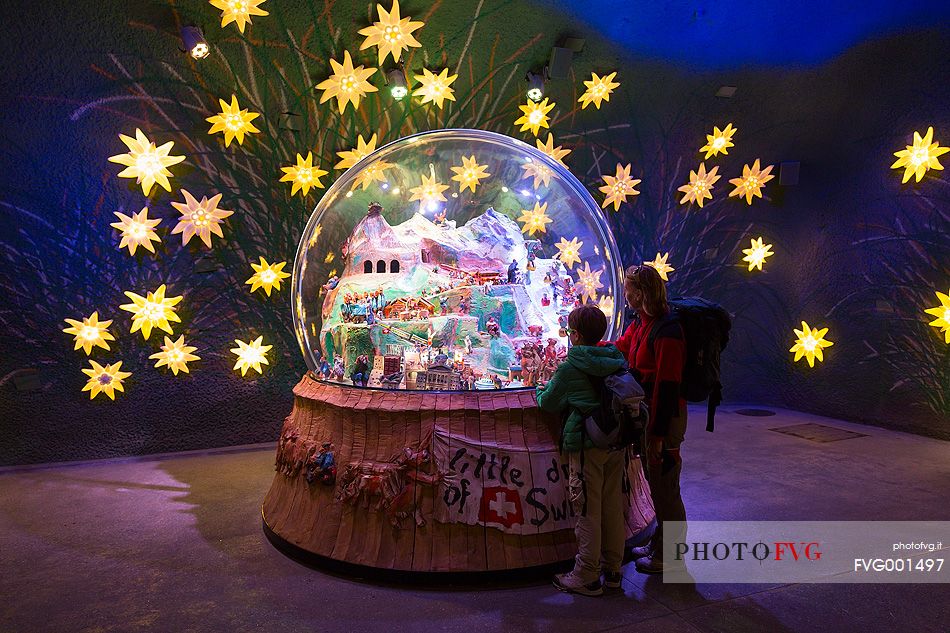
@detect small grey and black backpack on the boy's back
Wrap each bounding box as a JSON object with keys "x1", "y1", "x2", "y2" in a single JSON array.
[{"x1": 584, "y1": 368, "x2": 648, "y2": 450}]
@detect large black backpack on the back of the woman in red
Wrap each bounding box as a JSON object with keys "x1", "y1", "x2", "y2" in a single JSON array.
[{"x1": 647, "y1": 297, "x2": 732, "y2": 431}]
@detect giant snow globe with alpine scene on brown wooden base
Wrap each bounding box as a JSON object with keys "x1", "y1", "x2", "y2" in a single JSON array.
[{"x1": 262, "y1": 130, "x2": 654, "y2": 573}]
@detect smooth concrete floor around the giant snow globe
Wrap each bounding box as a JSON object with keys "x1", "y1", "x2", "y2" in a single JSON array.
[{"x1": 0, "y1": 406, "x2": 950, "y2": 633}]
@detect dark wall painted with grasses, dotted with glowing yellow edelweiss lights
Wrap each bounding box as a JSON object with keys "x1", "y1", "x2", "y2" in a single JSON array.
[{"x1": 0, "y1": 0, "x2": 950, "y2": 464}]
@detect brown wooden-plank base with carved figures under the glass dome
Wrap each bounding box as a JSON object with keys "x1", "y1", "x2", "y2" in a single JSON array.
[{"x1": 261, "y1": 376, "x2": 654, "y2": 575}]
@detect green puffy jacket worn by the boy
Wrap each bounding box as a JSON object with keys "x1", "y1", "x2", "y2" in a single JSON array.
[{"x1": 538, "y1": 345, "x2": 627, "y2": 452}]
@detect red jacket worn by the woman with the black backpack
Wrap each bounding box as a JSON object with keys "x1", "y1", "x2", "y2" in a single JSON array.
[{"x1": 616, "y1": 314, "x2": 686, "y2": 437}]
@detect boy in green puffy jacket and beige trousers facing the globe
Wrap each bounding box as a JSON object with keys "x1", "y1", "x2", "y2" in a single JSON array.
[{"x1": 538, "y1": 305, "x2": 626, "y2": 596}]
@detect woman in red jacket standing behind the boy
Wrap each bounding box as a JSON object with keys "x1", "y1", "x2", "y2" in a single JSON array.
[{"x1": 616, "y1": 265, "x2": 686, "y2": 574}]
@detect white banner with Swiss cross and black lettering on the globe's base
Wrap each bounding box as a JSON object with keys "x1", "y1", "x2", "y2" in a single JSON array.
[{"x1": 432, "y1": 428, "x2": 574, "y2": 534}]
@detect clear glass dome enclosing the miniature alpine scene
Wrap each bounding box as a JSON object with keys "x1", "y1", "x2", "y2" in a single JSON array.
[{"x1": 292, "y1": 130, "x2": 623, "y2": 391}]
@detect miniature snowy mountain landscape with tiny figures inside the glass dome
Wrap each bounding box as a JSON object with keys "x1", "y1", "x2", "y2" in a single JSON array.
[{"x1": 321, "y1": 203, "x2": 575, "y2": 389}]
